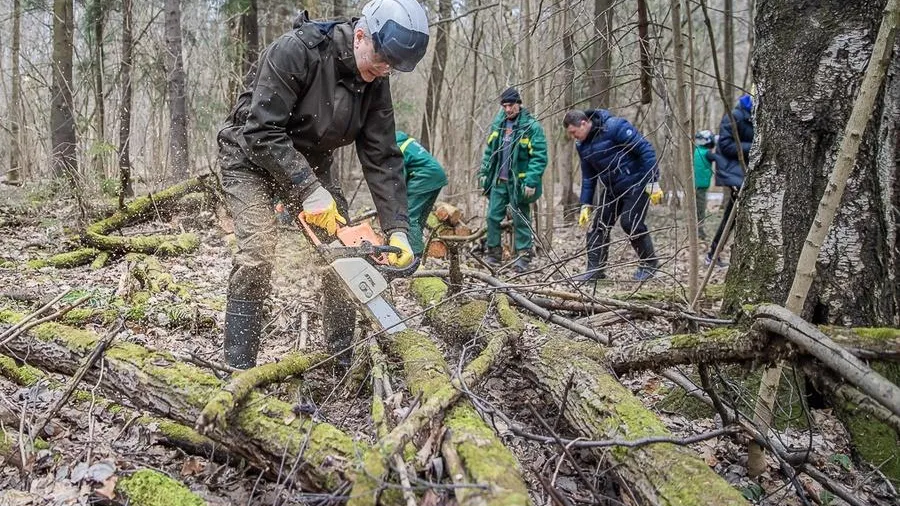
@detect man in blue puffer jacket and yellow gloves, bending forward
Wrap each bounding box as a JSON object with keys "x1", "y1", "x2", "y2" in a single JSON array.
[{"x1": 563, "y1": 109, "x2": 663, "y2": 281}]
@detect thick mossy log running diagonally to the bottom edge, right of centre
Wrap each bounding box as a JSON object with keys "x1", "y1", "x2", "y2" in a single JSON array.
[{"x1": 525, "y1": 333, "x2": 747, "y2": 506}]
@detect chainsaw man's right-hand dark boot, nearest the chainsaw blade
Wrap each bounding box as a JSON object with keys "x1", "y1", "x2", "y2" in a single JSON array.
[{"x1": 322, "y1": 273, "x2": 356, "y2": 370}]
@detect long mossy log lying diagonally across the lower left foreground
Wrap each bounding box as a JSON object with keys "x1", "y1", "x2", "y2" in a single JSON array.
[{"x1": 0, "y1": 311, "x2": 364, "y2": 490}]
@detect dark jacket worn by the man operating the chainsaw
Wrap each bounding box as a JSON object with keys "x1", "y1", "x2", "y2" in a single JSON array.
[{"x1": 218, "y1": 12, "x2": 409, "y2": 233}]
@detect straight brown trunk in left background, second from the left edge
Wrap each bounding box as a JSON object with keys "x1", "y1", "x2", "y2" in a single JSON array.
[{"x1": 50, "y1": 0, "x2": 80, "y2": 186}]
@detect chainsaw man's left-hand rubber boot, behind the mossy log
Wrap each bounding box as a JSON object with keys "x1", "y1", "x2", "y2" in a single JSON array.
[{"x1": 223, "y1": 299, "x2": 265, "y2": 369}]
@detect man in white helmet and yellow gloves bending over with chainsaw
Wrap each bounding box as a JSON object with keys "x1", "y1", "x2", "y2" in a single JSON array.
[{"x1": 218, "y1": 0, "x2": 428, "y2": 369}]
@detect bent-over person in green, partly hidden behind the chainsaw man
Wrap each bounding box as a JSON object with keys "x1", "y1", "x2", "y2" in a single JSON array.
[{"x1": 396, "y1": 130, "x2": 447, "y2": 257}]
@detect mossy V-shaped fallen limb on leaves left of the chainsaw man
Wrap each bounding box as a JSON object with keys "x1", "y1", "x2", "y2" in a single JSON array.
[{"x1": 83, "y1": 176, "x2": 207, "y2": 255}]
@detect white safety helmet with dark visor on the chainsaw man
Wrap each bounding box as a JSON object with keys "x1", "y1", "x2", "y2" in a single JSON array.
[{"x1": 362, "y1": 0, "x2": 428, "y2": 72}]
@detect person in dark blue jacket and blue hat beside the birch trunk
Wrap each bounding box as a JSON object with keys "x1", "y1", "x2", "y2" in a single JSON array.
[{"x1": 704, "y1": 95, "x2": 753, "y2": 267}]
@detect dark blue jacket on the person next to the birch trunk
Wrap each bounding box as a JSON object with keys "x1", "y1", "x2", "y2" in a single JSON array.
[{"x1": 715, "y1": 101, "x2": 753, "y2": 186}]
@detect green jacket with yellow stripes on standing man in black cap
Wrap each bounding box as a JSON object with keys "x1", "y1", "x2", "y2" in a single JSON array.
[{"x1": 479, "y1": 107, "x2": 547, "y2": 204}]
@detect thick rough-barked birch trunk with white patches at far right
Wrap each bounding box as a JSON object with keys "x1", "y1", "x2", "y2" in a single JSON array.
[{"x1": 725, "y1": 0, "x2": 900, "y2": 327}]
